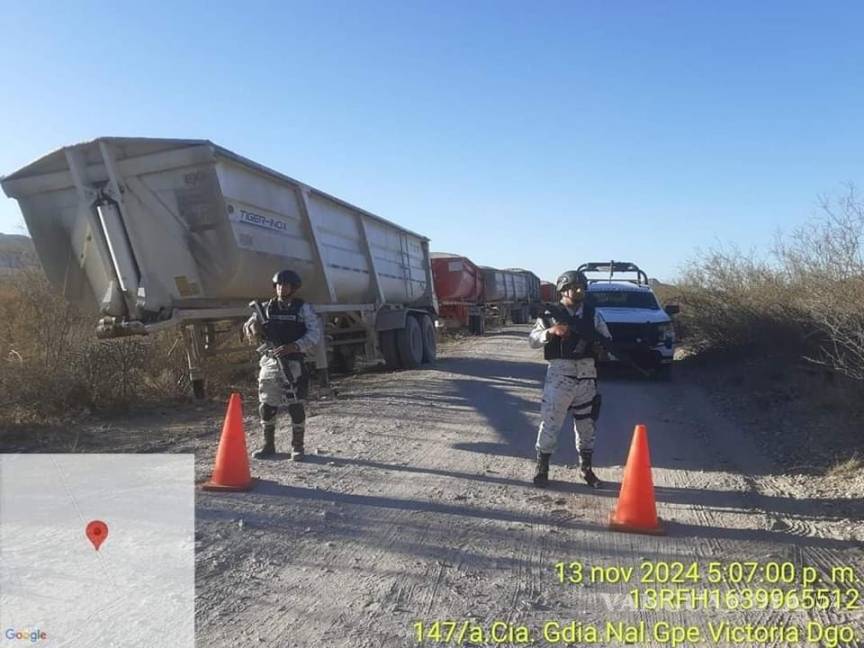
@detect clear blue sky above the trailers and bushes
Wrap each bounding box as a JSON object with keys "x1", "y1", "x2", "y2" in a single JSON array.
[{"x1": 0, "y1": 0, "x2": 864, "y2": 280}]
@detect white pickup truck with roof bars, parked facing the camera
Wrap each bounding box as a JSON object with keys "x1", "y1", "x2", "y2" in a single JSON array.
[{"x1": 578, "y1": 261, "x2": 678, "y2": 377}]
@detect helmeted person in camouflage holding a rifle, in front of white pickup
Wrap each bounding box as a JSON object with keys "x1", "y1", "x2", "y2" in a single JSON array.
[{"x1": 529, "y1": 270, "x2": 612, "y2": 488}]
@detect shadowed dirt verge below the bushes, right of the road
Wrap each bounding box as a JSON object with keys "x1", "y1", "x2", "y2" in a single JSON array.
[{"x1": 679, "y1": 350, "x2": 864, "y2": 543}]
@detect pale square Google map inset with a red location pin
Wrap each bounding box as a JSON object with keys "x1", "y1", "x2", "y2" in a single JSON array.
[{"x1": 0, "y1": 454, "x2": 195, "y2": 648}]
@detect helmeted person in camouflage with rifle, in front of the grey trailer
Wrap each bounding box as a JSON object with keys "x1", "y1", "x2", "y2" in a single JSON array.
[{"x1": 243, "y1": 270, "x2": 321, "y2": 461}]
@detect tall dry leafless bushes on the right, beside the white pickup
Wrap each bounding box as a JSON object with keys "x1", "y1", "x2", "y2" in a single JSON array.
[{"x1": 677, "y1": 188, "x2": 864, "y2": 381}]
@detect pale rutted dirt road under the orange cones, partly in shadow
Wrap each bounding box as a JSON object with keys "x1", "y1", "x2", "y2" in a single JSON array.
[{"x1": 191, "y1": 327, "x2": 864, "y2": 648}]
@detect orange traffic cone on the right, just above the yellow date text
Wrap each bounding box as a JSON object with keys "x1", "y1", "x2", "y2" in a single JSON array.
[{"x1": 609, "y1": 425, "x2": 666, "y2": 535}]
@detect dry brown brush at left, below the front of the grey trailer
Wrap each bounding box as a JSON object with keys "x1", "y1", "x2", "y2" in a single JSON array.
[{"x1": 0, "y1": 269, "x2": 186, "y2": 420}]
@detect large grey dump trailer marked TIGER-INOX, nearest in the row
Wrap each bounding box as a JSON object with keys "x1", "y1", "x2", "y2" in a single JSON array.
[{"x1": 0, "y1": 138, "x2": 437, "y2": 395}]
